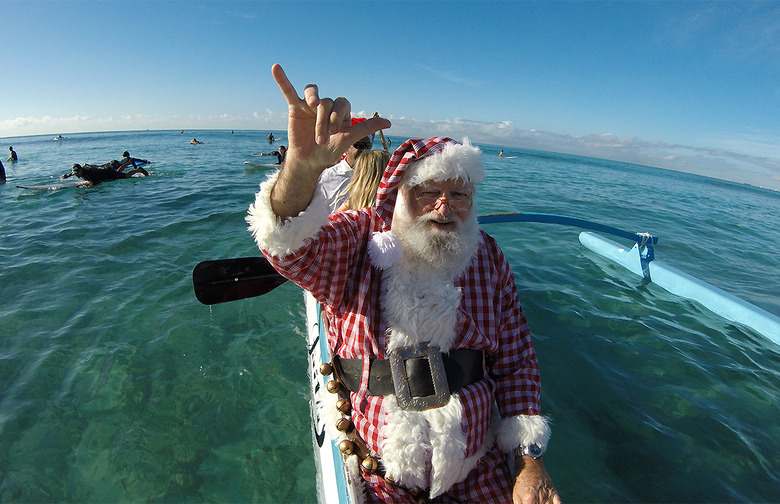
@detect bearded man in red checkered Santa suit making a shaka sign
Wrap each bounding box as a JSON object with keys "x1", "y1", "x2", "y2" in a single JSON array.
[{"x1": 247, "y1": 65, "x2": 561, "y2": 504}]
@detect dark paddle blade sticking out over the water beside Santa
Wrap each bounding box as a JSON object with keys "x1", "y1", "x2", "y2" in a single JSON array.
[{"x1": 192, "y1": 257, "x2": 287, "y2": 305}]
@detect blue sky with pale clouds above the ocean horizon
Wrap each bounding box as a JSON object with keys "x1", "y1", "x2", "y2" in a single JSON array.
[{"x1": 0, "y1": 0, "x2": 780, "y2": 190}]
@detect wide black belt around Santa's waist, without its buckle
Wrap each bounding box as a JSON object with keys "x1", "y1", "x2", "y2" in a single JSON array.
[{"x1": 333, "y1": 348, "x2": 484, "y2": 397}]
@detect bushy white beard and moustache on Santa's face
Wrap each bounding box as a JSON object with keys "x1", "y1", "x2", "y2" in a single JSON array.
[{"x1": 391, "y1": 194, "x2": 481, "y2": 279}]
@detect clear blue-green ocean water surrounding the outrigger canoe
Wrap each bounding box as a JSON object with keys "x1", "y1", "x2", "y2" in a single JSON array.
[{"x1": 0, "y1": 131, "x2": 780, "y2": 503}]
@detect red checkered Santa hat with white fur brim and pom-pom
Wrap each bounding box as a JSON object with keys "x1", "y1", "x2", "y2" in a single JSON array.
[{"x1": 369, "y1": 137, "x2": 485, "y2": 269}]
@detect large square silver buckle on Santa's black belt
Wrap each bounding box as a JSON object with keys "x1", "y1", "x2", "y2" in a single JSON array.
[{"x1": 389, "y1": 343, "x2": 450, "y2": 411}]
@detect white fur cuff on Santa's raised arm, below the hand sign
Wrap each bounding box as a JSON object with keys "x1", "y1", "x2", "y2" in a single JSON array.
[{"x1": 246, "y1": 171, "x2": 329, "y2": 256}]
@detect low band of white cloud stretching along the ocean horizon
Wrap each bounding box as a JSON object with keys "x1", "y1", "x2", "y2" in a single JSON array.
[{"x1": 0, "y1": 109, "x2": 780, "y2": 190}]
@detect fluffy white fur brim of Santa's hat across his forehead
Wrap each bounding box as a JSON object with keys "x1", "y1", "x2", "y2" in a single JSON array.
[{"x1": 404, "y1": 138, "x2": 485, "y2": 187}]
